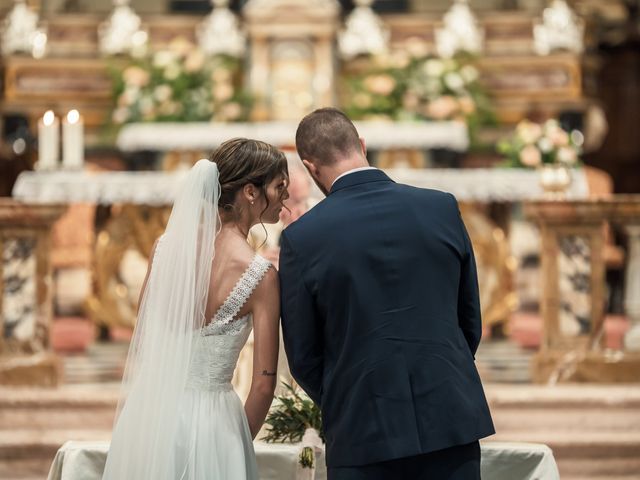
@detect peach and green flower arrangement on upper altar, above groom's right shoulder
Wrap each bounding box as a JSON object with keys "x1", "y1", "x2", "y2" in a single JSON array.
[{"x1": 343, "y1": 53, "x2": 494, "y2": 130}]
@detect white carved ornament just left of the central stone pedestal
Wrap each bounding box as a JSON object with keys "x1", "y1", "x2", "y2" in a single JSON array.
[{"x1": 196, "y1": 0, "x2": 246, "y2": 57}]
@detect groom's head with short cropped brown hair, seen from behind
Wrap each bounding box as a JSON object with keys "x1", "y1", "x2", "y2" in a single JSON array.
[{"x1": 296, "y1": 108, "x2": 368, "y2": 194}]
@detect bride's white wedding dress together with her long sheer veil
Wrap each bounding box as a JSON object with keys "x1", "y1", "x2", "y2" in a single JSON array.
[{"x1": 103, "y1": 160, "x2": 271, "y2": 480}]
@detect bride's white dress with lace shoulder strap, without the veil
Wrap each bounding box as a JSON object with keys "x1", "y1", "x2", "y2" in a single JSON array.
[{"x1": 105, "y1": 244, "x2": 271, "y2": 480}]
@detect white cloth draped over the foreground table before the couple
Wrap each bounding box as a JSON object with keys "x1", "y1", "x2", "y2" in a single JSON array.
[{"x1": 48, "y1": 442, "x2": 560, "y2": 480}]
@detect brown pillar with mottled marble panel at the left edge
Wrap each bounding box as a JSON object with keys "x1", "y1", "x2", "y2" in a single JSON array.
[{"x1": 0, "y1": 199, "x2": 66, "y2": 386}]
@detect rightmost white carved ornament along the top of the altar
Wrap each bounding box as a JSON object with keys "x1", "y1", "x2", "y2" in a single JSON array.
[{"x1": 533, "y1": 0, "x2": 584, "y2": 55}]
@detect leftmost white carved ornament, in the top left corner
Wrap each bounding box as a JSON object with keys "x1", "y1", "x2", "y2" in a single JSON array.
[{"x1": 2, "y1": 0, "x2": 47, "y2": 58}]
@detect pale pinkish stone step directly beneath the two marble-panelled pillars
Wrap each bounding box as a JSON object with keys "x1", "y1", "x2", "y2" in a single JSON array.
[{"x1": 5, "y1": 383, "x2": 640, "y2": 433}]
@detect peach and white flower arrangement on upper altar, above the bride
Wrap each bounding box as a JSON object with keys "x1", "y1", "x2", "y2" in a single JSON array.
[{"x1": 111, "y1": 39, "x2": 251, "y2": 125}]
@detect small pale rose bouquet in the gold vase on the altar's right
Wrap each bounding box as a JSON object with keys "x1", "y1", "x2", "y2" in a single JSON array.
[{"x1": 498, "y1": 119, "x2": 582, "y2": 168}]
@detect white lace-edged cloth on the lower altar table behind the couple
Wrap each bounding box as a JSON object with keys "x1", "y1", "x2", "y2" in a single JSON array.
[{"x1": 13, "y1": 168, "x2": 588, "y2": 205}]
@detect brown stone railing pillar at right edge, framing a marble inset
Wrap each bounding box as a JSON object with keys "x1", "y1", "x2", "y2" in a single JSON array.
[{"x1": 524, "y1": 195, "x2": 640, "y2": 383}]
